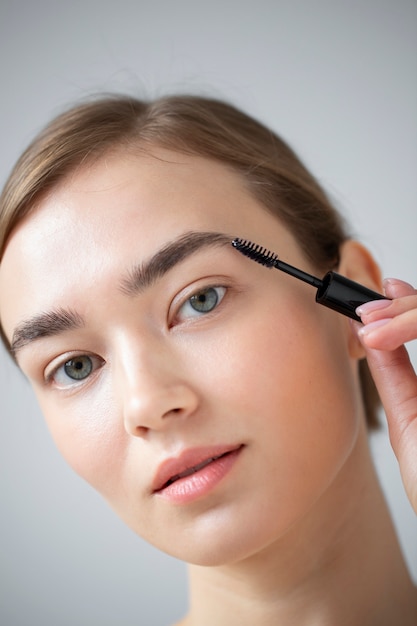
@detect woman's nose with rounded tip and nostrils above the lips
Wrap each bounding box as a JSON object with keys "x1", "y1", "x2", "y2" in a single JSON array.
[{"x1": 117, "y1": 346, "x2": 199, "y2": 437}]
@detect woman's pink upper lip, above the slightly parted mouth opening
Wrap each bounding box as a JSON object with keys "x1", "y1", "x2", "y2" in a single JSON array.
[{"x1": 152, "y1": 445, "x2": 243, "y2": 493}]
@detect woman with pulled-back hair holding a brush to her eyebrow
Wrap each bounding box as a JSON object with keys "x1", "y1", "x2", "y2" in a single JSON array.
[{"x1": 0, "y1": 97, "x2": 417, "y2": 626}]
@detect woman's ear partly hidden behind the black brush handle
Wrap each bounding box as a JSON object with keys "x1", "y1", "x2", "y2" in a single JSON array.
[{"x1": 337, "y1": 239, "x2": 383, "y2": 359}]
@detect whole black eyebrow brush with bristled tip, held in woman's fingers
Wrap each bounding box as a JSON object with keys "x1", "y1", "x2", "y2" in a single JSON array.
[{"x1": 231, "y1": 238, "x2": 388, "y2": 322}]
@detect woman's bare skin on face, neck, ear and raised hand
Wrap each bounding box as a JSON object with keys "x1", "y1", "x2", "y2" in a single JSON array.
[{"x1": 0, "y1": 148, "x2": 417, "y2": 626}]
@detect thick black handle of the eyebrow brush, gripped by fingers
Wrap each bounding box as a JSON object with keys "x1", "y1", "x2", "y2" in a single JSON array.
[{"x1": 316, "y1": 272, "x2": 388, "y2": 322}]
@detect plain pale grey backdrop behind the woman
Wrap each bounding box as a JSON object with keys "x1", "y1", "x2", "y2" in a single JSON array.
[{"x1": 0, "y1": 0, "x2": 417, "y2": 626}]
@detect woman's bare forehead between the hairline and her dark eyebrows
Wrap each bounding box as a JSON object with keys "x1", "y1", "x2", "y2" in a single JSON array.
[{"x1": 0, "y1": 150, "x2": 292, "y2": 342}]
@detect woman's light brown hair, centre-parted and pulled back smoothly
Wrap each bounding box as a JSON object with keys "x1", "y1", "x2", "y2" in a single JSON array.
[{"x1": 0, "y1": 95, "x2": 379, "y2": 427}]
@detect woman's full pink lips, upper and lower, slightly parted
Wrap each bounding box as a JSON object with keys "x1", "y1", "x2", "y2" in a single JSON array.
[{"x1": 152, "y1": 445, "x2": 243, "y2": 504}]
